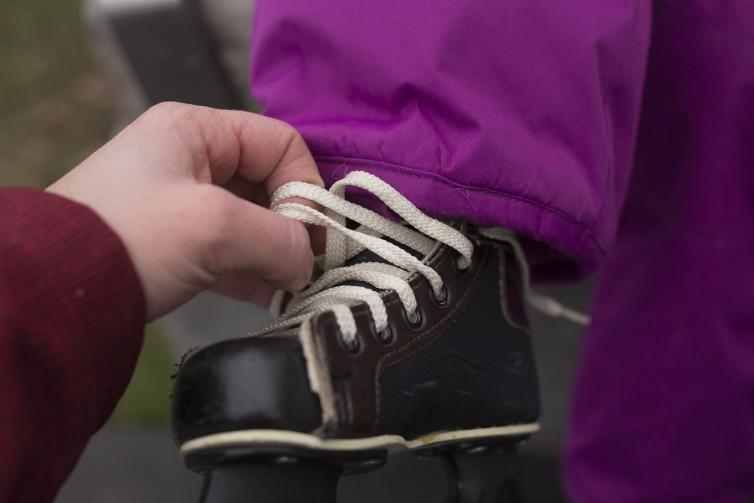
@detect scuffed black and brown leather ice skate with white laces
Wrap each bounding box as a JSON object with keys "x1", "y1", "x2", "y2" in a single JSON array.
[{"x1": 173, "y1": 172, "x2": 539, "y2": 502}]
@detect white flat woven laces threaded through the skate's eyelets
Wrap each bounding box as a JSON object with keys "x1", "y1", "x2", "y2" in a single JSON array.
[{"x1": 265, "y1": 171, "x2": 588, "y2": 348}]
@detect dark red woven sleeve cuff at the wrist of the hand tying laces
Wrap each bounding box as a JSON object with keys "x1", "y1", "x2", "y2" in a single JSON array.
[{"x1": 0, "y1": 189, "x2": 145, "y2": 503}]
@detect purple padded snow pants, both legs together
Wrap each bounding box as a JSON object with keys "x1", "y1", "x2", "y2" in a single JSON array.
[{"x1": 252, "y1": 0, "x2": 754, "y2": 503}]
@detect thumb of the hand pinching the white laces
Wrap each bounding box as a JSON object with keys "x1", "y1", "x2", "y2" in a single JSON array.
[{"x1": 201, "y1": 190, "x2": 314, "y2": 290}]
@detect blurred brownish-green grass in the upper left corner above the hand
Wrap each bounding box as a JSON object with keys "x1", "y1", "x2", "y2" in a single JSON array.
[{"x1": 0, "y1": 0, "x2": 112, "y2": 187}]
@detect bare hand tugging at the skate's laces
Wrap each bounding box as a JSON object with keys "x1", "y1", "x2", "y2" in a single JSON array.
[{"x1": 48, "y1": 103, "x2": 322, "y2": 320}]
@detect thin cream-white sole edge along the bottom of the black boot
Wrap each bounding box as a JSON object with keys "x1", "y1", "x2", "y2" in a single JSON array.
[{"x1": 181, "y1": 423, "x2": 539, "y2": 456}]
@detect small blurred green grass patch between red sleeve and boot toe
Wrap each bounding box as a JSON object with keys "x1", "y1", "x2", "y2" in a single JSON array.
[{"x1": 110, "y1": 325, "x2": 174, "y2": 427}]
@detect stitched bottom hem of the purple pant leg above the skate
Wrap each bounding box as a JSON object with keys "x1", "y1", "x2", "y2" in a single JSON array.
[{"x1": 315, "y1": 155, "x2": 605, "y2": 276}]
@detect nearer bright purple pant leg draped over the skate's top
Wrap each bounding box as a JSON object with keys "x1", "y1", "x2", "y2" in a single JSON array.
[{"x1": 252, "y1": 0, "x2": 649, "y2": 280}]
